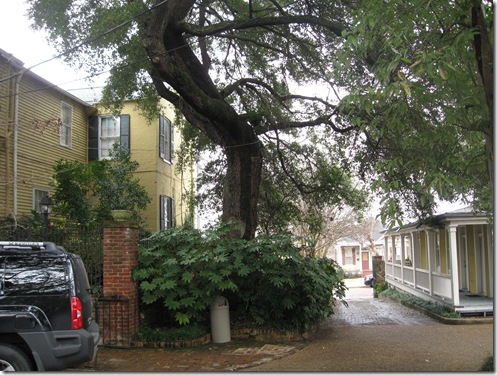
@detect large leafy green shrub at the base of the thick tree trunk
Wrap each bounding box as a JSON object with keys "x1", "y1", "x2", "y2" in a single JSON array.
[{"x1": 134, "y1": 224, "x2": 345, "y2": 330}]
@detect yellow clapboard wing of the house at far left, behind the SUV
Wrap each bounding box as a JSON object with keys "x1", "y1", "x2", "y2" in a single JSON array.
[{"x1": 0, "y1": 49, "x2": 91, "y2": 217}]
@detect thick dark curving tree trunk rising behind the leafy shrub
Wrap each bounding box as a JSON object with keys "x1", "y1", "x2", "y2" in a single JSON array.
[{"x1": 143, "y1": 0, "x2": 262, "y2": 239}]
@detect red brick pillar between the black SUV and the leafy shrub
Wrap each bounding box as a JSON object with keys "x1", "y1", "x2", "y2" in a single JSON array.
[{"x1": 99, "y1": 221, "x2": 139, "y2": 346}]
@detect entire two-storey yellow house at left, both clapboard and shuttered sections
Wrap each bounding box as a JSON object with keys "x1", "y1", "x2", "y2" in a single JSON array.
[{"x1": 0, "y1": 49, "x2": 195, "y2": 231}]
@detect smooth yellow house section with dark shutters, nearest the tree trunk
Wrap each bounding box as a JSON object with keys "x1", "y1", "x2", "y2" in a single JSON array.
[{"x1": 88, "y1": 100, "x2": 195, "y2": 231}]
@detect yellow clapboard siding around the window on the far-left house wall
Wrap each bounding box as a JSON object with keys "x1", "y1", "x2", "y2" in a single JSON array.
[{"x1": 0, "y1": 64, "x2": 87, "y2": 215}]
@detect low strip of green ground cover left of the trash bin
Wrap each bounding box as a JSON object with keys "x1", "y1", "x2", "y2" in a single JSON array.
[{"x1": 133, "y1": 325, "x2": 209, "y2": 342}]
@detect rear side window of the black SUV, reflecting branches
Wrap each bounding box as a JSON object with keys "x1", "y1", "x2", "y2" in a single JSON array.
[{"x1": 0, "y1": 255, "x2": 68, "y2": 296}]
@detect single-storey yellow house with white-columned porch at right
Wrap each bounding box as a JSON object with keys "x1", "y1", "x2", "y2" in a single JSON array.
[{"x1": 385, "y1": 208, "x2": 494, "y2": 315}]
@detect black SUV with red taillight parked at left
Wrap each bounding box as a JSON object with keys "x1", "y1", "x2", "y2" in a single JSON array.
[{"x1": 0, "y1": 241, "x2": 100, "y2": 371}]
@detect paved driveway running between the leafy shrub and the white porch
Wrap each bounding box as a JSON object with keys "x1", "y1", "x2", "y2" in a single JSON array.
[{"x1": 244, "y1": 279, "x2": 494, "y2": 372}]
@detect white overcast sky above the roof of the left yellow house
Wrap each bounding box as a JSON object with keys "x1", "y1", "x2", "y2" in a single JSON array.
[{"x1": 0, "y1": 0, "x2": 102, "y2": 95}]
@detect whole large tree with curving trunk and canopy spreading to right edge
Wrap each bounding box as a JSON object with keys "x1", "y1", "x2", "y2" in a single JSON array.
[{"x1": 29, "y1": 0, "x2": 493, "y2": 239}]
